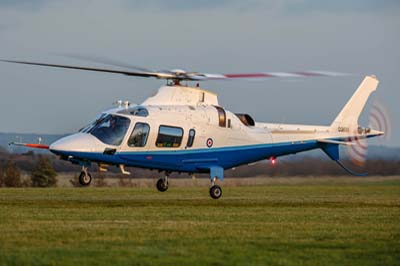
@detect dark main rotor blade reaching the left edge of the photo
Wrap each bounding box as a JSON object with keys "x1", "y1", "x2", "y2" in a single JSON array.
[{"x1": 0, "y1": 59, "x2": 159, "y2": 78}]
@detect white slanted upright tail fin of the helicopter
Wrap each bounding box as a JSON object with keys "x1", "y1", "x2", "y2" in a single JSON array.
[{"x1": 331, "y1": 76, "x2": 379, "y2": 131}]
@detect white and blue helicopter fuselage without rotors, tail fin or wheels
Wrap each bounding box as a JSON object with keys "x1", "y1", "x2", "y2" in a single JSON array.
[{"x1": 50, "y1": 81, "x2": 379, "y2": 179}]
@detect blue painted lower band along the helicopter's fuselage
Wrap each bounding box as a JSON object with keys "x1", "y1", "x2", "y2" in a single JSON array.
[{"x1": 52, "y1": 140, "x2": 319, "y2": 172}]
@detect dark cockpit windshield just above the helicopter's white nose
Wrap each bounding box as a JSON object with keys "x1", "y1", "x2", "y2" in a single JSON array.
[{"x1": 88, "y1": 115, "x2": 130, "y2": 146}]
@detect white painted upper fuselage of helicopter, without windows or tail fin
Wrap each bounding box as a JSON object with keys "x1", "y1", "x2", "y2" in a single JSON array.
[{"x1": 50, "y1": 83, "x2": 380, "y2": 158}]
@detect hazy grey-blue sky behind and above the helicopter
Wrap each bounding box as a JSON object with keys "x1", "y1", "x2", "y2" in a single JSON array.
[{"x1": 0, "y1": 0, "x2": 400, "y2": 146}]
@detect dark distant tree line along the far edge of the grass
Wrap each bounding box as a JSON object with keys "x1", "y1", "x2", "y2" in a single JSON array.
[{"x1": 0, "y1": 147, "x2": 400, "y2": 187}]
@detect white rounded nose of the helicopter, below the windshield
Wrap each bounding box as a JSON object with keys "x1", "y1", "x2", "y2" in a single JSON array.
[{"x1": 49, "y1": 133, "x2": 104, "y2": 154}]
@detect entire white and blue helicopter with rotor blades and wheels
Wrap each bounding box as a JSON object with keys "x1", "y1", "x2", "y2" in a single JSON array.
[{"x1": 1, "y1": 60, "x2": 384, "y2": 199}]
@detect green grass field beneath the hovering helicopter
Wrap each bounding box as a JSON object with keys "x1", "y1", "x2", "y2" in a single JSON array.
[{"x1": 0, "y1": 178, "x2": 400, "y2": 266}]
